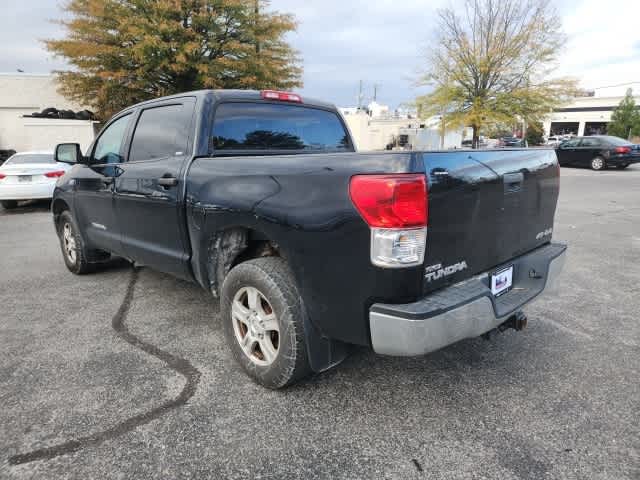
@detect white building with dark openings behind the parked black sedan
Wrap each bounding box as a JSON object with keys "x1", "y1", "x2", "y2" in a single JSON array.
[{"x1": 544, "y1": 97, "x2": 640, "y2": 136}]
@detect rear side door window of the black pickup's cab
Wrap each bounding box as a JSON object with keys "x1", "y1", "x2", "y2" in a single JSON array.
[{"x1": 129, "y1": 103, "x2": 192, "y2": 162}]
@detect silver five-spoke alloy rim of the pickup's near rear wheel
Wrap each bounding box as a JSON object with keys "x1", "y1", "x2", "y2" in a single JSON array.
[{"x1": 231, "y1": 287, "x2": 280, "y2": 366}]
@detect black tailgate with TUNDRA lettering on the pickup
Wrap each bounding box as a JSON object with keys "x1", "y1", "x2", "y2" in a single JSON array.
[{"x1": 422, "y1": 149, "x2": 560, "y2": 293}]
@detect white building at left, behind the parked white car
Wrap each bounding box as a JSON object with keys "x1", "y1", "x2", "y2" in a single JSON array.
[{"x1": 0, "y1": 73, "x2": 97, "y2": 152}]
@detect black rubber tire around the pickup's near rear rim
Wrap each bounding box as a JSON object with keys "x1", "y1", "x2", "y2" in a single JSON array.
[{"x1": 220, "y1": 257, "x2": 311, "y2": 389}]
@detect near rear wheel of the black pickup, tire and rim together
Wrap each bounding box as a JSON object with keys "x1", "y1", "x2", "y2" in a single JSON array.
[{"x1": 220, "y1": 257, "x2": 311, "y2": 389}]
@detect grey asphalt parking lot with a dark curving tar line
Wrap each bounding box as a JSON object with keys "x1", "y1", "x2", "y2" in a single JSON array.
[{"x1": 0, "y1": 165, "x2": 640, "y2": 479}]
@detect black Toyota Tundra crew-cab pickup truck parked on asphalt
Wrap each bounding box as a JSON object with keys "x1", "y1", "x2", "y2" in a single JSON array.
[{"x1": 52, "y1": 90, "x2": 566, "y2": 388}]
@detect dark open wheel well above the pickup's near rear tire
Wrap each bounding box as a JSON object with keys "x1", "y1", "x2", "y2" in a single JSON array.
[{"x1": 207, "y1": 227, "x2": 282, "y2": 297}]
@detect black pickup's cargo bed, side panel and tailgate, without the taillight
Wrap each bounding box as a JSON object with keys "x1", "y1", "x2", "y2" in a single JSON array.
[{"x1": 186, "y1": 149, "x2": 559, "y2": 345}]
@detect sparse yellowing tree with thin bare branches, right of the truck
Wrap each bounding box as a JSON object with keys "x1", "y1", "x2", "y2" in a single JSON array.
[{"x1": 417, "y1": 0, "x2": 575, "y2": 148}]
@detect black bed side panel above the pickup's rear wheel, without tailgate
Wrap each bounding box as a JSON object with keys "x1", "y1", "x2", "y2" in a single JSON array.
[{"x1": 187, "y1": 153, "x2": 424, "y2": 345}]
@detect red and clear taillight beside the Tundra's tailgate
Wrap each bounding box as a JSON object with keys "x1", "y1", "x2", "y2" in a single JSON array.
[{"x1": 349, "y1": 174, "x2": 428, "y2": 268}]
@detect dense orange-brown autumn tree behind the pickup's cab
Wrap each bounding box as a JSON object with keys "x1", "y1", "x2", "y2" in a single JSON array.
[{"x1": 45, "y1": 0, "x2": 302, "y2": 119}]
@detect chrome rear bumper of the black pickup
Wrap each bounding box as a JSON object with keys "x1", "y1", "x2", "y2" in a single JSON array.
[{"x1": 369, "y1": 243, "x2": 567, "y2": 356}]
